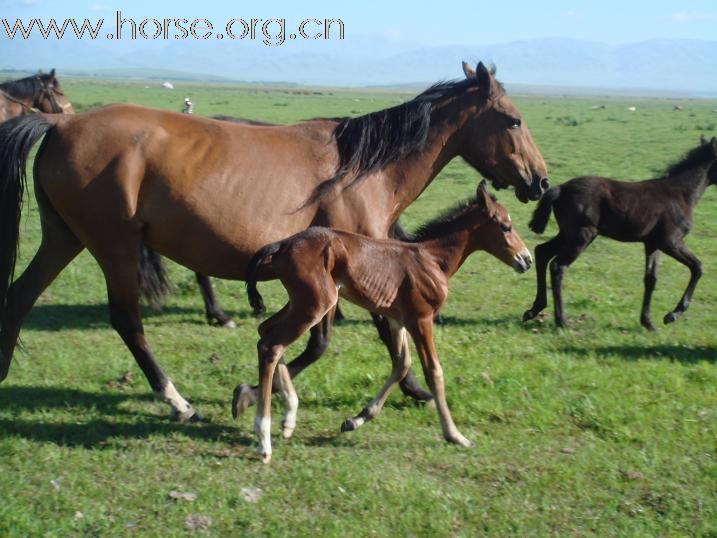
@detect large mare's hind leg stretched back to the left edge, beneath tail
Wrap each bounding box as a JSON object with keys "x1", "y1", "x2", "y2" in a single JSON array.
[{"x1": 0, "y1": 207, "x2": 83, "y2": 381}]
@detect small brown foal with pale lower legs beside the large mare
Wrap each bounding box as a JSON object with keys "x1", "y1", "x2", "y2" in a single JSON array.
[{"x1": 241, "y1": 183, "x2": 531, "y2": 462}]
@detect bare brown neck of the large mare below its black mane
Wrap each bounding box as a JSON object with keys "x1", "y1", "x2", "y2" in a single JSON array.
[{"x1": 383, "y1": 100, "x2": 467, "y2": 222}]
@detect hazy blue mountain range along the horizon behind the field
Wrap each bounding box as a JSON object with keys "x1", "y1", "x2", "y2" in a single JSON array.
[{"x1": 0, "y1": 35, "x2": 717, "y2": 96}]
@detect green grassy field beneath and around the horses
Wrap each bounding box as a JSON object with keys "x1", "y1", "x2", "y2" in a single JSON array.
[{"x1": 0, "y1": 74, "x2": 717, "y2": 537}]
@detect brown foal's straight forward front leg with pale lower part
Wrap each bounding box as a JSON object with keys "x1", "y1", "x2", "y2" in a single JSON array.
[{"x1": 408, "y1": 317, "x2": 471, "y2": 447}]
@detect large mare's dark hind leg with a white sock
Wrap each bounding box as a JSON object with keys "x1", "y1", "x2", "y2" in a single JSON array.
[{"x1": 95, "y1": 238, "x2": 202, "y2": 422}]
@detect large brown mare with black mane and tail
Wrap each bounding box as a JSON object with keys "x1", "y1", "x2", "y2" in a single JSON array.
[{"x1": 0, "y1": 64, "x2": 547, "y2": 420}]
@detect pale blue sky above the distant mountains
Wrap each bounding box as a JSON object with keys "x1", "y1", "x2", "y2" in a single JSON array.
[{"x1": 0, "y1": 0, "x2": 717, "y2": 46}]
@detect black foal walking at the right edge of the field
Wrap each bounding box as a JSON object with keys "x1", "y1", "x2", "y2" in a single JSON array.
[{"x1": 523, "y1": 138, "x2": 717, "y2": 330}]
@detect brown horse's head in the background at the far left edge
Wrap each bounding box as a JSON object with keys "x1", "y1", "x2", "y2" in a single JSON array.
[{"x1": 0, "y1": 69, "x2": 74, "y2": 122}]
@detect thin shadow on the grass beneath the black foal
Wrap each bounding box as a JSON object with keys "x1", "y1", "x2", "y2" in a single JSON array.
[{"x1": 559, "y1": 344, "x2": 717, "y2": 364}]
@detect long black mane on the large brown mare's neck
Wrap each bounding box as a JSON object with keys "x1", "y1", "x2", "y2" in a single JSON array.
[{"x1": 302, "y1": 78, "x2": 502, "y2": 207}]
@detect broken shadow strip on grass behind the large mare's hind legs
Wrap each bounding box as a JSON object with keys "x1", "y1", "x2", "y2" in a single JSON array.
[{"x1": 23, "y1": 304, "x2": 251, "y2": 331}]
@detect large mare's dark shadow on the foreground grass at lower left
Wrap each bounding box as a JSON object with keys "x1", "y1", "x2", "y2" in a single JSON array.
[{"x1": 0, "y1": 387, "x2": 253, "y2": 448}]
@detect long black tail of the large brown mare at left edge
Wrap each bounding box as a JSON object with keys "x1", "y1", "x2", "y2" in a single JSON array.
[{"x1": 0, "y1": 114, "x2": 54, "y2": 320}]
